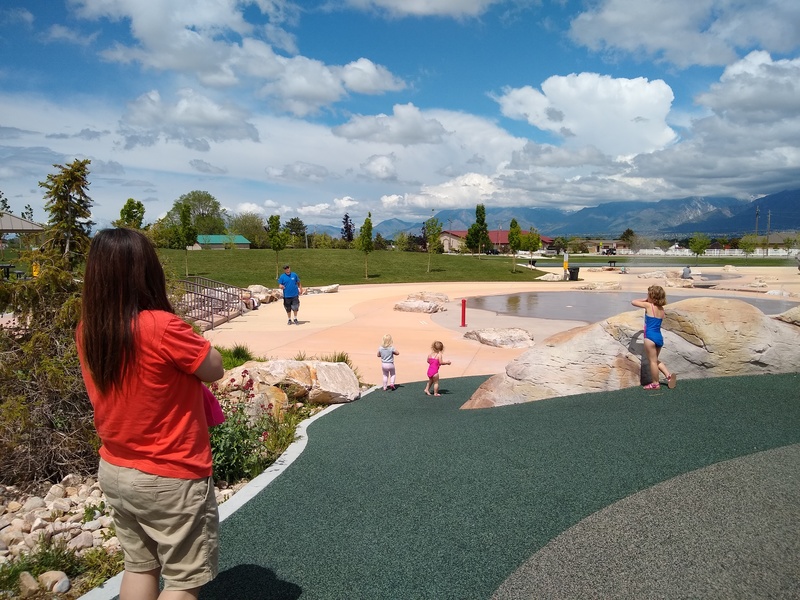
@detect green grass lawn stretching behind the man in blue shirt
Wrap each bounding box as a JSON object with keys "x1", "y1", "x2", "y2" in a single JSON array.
[{"x1": 159, "y1": 248, "x2": 796, "y2": 287}]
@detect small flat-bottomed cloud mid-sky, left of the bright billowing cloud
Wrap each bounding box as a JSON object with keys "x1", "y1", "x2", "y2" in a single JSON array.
[{"x1": 333, "y1": 103, "x2": 447, "y2": 146}]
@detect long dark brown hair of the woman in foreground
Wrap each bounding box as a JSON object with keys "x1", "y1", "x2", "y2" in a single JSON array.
[{"x1": 81, "y1": 229, "x2": 175, "y2": 394}]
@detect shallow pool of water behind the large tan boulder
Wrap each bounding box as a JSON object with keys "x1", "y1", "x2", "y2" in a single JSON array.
[{"x1": 467, "y1": 290, "x2": 800, "y2": 323}]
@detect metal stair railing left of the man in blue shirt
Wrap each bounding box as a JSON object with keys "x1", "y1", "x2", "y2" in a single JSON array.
[{"x1": 175, "y1": 277, "x2": 247, "y2": 329}]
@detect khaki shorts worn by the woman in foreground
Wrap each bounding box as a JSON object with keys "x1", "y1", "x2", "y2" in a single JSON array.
[{"x1": 98, "y1": 459, "x2": 219, "y2": 590}]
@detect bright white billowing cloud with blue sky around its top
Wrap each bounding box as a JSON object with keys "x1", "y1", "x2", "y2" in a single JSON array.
[{"x1": 494, "y1": 73, "x2": 675, "y2": 155}]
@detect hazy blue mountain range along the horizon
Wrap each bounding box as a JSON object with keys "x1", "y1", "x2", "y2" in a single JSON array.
[{"x1": 308, "y1": 189, "x2": 800, "y2": 239}]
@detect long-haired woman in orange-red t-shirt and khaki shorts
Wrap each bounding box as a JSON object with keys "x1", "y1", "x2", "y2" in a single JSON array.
[{"x1": 76, "y1": 229, "x2": 223, "y2": 600}]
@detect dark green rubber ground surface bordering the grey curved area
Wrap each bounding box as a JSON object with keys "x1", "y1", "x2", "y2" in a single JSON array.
[{"x1": 200, "y1": 374, "x2": 800, "y2": 600}]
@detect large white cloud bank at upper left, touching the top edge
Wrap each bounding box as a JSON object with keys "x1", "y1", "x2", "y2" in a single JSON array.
[{"x1": 73, "y1": 0, "x2": 405, "y2": 116}]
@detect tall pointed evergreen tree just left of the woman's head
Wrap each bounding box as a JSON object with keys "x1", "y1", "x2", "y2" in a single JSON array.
[{"x1": 39, "y1": 158, "x2": 94, "y2": 269}]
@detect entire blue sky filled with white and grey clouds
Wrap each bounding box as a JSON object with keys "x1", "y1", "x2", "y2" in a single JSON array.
[{"x1": 0, "y1": 0, "x2": 800, "y2": 227}]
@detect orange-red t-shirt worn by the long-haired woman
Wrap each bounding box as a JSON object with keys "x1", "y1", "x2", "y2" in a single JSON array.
[{"x1": 76, "y1": 310, "x2": 211, "y2": 479}]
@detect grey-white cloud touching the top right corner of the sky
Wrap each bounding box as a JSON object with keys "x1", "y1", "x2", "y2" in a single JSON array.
[{"x1": 570, "y1": 0, "x2": 800, "y2": 67}]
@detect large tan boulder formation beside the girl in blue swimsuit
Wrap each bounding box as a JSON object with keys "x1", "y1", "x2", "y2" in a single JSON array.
[{"x1": 462, "y1": 298, "x2": 800, "y2": 408}]
